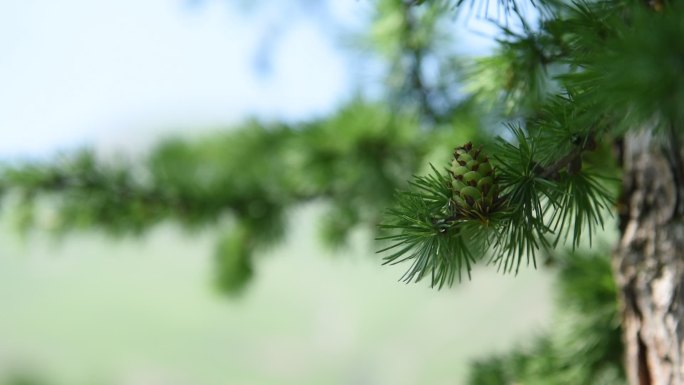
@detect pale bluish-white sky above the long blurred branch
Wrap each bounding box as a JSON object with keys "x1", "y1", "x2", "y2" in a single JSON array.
[{"x1": 0, "y1": 0, "x2": 363, "y2": 158}]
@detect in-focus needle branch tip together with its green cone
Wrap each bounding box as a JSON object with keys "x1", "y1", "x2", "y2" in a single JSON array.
[{"x1": 382, "y1": 126, "x2": 612, "y2": 287}]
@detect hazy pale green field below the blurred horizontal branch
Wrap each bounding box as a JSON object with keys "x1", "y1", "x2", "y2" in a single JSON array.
[{"x1": 0, "y1": 205, "x2": 552, "y2": 385}]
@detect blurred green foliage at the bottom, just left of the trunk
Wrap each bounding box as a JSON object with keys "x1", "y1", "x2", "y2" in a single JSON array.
[{"x1": 468, "y1": 245, "x2": 625, "y2": 385}]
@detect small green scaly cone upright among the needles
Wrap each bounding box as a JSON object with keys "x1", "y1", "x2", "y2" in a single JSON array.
[{"x1": 450, "y1": 142, "x2": 499, "y2": 219}]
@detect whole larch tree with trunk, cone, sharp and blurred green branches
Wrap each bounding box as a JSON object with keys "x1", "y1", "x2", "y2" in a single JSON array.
[{"x1": 0, "y1": 0, "x2": 684, "y2": 385}]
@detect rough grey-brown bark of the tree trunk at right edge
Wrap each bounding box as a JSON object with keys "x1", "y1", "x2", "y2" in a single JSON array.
[{"x1": 613, "y1": 133, "x2": 684, "y2": 385}]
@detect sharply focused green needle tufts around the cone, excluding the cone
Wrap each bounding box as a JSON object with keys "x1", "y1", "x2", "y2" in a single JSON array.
[{"x1": 379, "y1": 125, "x2": 612, "y2": 288}]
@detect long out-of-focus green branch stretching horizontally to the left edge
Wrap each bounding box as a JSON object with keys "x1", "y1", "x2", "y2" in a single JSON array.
[{"x1": 2, "y1": 100, "x2": 460, "y2": 289}]
